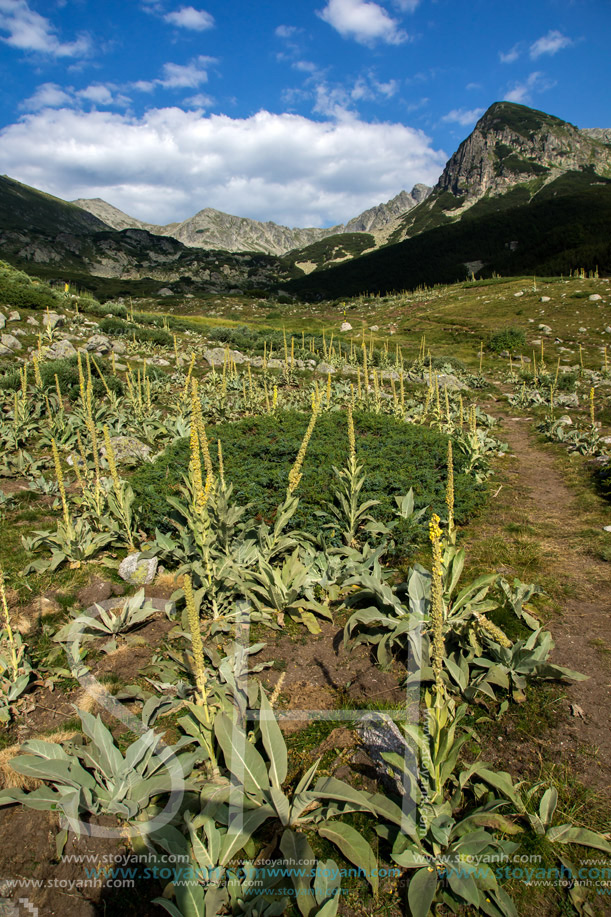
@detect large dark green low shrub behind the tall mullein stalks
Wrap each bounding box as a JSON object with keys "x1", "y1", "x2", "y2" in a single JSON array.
[{"x1": 130, "y1": 411, "x2": 485, "y2": 551}]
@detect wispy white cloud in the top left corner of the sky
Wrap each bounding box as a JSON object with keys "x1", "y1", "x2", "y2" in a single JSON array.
[{"x1": 0, "y1": 0, "x2": 91, "y2": 57}]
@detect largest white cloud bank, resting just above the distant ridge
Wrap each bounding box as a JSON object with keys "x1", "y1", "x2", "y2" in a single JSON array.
[{"x1": 0, "y1": 108, "x2": 447, "y2": 226}]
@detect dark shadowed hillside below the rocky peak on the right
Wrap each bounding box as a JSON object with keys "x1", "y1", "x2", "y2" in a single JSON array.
[{"x1": 287, "y1": 172, "x2": 611, "y2": 299}]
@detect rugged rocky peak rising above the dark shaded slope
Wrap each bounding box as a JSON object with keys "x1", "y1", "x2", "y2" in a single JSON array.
[{"x1": 434, "y1": 102, "x2": 611, "y2": 202}]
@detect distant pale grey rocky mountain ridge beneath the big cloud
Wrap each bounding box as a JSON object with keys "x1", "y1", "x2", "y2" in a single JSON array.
[{"x1": 72, "y1": 184, "x2": 431, "y2": 255}]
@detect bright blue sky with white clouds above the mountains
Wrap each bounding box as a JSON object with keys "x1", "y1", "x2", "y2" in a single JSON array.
[{"x1": 0, "y1": 0, "x2": 611, "y2": 226}]
